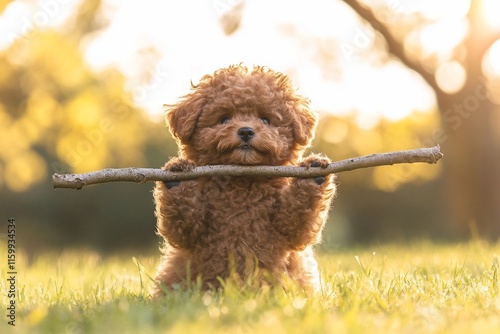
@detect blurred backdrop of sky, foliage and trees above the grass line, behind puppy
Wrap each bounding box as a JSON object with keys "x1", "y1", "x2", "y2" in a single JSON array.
[{"x1": 0, "y1": 0, "x2": 500, "y2": 254}]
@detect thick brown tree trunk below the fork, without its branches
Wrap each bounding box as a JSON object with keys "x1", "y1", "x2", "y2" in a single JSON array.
[{"x1": 438, "y1": 82, "x2": 500, "y2": 240}]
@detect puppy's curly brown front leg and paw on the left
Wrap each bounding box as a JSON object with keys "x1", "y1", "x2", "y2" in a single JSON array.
[{"x1": 154, "y1": 158, "x2": 205, "y2": 249}]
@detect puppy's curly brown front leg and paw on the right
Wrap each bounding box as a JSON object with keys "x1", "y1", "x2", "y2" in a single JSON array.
[{"x1": 279, "y1": 154, "x2": 335, "y2": 249}]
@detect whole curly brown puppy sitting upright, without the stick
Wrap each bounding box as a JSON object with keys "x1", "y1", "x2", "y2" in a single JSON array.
[{"x1": 154, "y1": 65, "x2": 335, "y2": 296}]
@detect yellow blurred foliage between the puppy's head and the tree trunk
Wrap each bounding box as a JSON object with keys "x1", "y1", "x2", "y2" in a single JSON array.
[{"x1": 313, "y1": 112, "x2": 440, "y2": 191}]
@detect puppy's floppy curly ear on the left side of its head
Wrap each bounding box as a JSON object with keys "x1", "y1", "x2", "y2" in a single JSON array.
[{"x1": 163, "y1": 93, "x2": 205, "y2": 143}]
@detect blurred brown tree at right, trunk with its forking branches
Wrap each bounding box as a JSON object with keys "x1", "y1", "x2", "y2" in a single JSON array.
[{"x1": 344, "y1": 0, "x2": 500, "y2": 240}]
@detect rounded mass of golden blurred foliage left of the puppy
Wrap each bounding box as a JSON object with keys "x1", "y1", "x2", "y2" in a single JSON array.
[{"x1": 0, "y1": 31, "x2": 154, "y2": 192}]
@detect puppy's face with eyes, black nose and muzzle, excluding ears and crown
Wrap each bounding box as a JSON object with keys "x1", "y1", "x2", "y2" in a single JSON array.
[{"x1": 191, "y1": 104, "x2": 295, "y2": 165}]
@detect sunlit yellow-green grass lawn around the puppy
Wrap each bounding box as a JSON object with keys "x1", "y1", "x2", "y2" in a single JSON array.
[{"x1": 0, "y1": 242, "x2": 500, "y2": 334}]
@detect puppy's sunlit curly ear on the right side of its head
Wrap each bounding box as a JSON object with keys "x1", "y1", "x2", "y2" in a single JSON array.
[{"x1": 291, "y1": 99, "x2": 317, "y2": 146}]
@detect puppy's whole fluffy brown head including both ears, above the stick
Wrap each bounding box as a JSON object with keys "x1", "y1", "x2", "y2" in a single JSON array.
[{"x1": 168, "y1": 66, "x2": 316, "y2": 166}]
